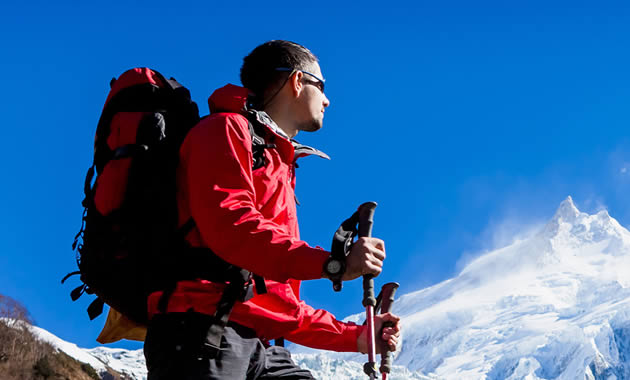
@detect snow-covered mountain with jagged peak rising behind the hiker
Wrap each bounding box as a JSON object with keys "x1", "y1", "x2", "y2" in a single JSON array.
[{"x1": 32, "y1": 197, "x2": 630, "y2": 380}]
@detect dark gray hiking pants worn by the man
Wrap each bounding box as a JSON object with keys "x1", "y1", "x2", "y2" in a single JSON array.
[{"x1": 144, "y1": 313, "x2": 314, "y2": 380}]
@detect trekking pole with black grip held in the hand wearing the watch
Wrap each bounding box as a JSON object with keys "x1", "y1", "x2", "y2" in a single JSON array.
[{"x1": 358, "y1": 202, "x2": 377, "y2": 380}]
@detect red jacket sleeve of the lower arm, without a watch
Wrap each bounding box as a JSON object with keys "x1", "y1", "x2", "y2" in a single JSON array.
[{"x1": 285, "y1": 302, "x2": 365, "y2": 352}]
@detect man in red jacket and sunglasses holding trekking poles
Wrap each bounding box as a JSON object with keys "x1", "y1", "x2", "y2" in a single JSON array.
[{"x1": 145, "y1": 41, "x2": 400, "y2": 380}]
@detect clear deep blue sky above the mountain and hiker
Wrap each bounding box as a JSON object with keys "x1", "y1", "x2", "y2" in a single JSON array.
[{"x1": 0, "y1": 1, "x2": 630, "y2": 348}]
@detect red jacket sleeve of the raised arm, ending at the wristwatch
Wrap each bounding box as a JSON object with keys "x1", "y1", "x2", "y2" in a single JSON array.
[{"x1": 180, "y1": 113, "x2": 328, "y2": 282}]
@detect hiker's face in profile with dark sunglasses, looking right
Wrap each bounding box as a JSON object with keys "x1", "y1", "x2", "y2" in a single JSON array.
[{"x1": 296, "y1": 63, "x2": 330, "y2": 132}]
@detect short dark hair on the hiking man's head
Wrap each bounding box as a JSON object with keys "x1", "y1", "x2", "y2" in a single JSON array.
[{"x1": 241, "y1": 40, "x2": 318, "y2": 100}]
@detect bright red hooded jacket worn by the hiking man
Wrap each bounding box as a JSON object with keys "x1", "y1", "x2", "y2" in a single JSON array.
[{"x1": 149, "y1": 85, "x2": 363, "y2": 352}]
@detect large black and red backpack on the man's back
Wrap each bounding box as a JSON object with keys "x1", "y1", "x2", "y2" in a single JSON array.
[{"x1": 62, "y1": 68, "x2": 272, "y2": 328}]
